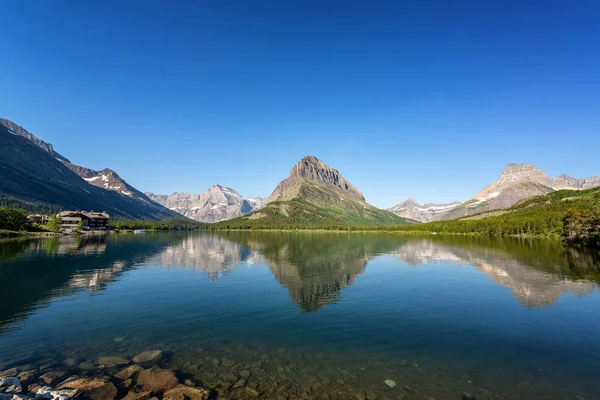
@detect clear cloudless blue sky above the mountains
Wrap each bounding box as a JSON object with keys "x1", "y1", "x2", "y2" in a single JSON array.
[{"x1": 0, "y1": 0, "x2": 600, "y2": 207}]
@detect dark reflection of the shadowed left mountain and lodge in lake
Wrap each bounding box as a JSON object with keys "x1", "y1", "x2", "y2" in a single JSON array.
[{"x1": 0, "y1": 235, "x2": 182, "y2": 333}]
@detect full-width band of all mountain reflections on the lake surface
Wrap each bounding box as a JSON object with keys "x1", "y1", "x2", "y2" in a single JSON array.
[{"x1": 0, "y1": 232, "x2": 600, "y2": 329}]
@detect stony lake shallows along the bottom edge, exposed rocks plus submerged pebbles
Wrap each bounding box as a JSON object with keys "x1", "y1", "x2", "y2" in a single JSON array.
[{"x1": 0, "y1": 337, "x2": 584, "y2": 400}]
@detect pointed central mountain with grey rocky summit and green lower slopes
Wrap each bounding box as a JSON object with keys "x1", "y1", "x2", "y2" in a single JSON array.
[{"x1": 212, "y1": 156, "x2": 408, "y2": 228}]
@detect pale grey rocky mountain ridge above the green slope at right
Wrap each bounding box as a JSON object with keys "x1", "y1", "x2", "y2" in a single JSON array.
[{"x1": 390, "y1": 164, "x2": 600, "y2": 222}]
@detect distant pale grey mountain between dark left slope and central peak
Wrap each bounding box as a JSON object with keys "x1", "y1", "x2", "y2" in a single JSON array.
[{"x1": 146, "y1": 185, "x2": 265, "y2": 222}]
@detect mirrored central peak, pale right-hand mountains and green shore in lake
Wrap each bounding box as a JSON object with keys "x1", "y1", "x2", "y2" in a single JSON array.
[{"x1": 219, "y1": 233, "x2": 600, "y2": 311}]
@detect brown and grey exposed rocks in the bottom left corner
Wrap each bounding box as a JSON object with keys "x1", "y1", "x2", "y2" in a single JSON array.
[{"x1": 0, "y1": 350, "x2": 213, "y2": 400}]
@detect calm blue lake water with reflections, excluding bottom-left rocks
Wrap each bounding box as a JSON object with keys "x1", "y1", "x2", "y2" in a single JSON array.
[{"x1": 0, "y1": 232, "x2": 600, "y2": 400}]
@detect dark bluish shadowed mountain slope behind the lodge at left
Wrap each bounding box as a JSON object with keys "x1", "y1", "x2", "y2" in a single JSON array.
[{"x1": 0, "y1": 119, "x2": 180, "y2": 220}]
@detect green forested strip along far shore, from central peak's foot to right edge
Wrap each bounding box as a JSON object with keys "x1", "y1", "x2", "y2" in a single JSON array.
[{"x1": 209, "y1": 188, "x2": 600, "y2": 247}]
